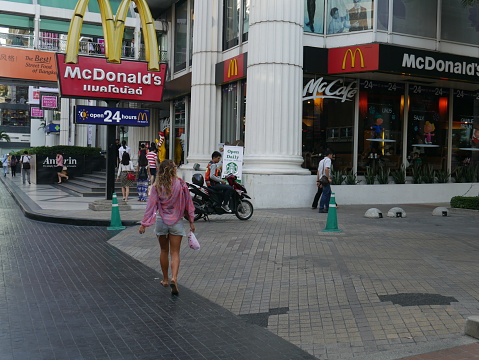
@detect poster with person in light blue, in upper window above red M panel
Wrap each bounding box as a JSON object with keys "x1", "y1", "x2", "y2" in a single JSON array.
[{"x1": 326, "y1": 0, "x2": 374, "y2": 35}]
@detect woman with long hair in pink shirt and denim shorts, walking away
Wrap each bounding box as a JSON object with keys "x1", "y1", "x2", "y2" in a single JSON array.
[{"x1": 139, "y1": 160, "x2": 195, "y2": 295}]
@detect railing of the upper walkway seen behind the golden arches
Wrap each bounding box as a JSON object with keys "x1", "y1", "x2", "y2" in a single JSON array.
[{"x1": 0, "y1": 32, "x2": 168, "y2": 62}]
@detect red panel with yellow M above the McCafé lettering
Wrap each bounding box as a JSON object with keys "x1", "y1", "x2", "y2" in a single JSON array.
[{"x1": 328, "y1": 44, "x2": 379, "y2": 74}]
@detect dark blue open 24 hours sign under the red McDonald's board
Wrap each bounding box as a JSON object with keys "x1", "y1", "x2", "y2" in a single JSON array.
[{"x1": 75, "y1": 105, "x2": 150, "y2": 126}]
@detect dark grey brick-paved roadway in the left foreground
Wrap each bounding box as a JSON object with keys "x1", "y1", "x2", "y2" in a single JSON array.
[{"x1": 0, "y1": 186, "x2": 313, "y2": 360}]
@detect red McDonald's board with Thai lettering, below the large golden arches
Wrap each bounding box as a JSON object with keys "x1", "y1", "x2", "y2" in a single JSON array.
[{"x1": 57, "y1": 54, "x2": 166, "y2": 101}]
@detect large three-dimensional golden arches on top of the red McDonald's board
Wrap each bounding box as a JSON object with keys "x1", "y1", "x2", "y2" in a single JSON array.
[{"x1": 65, "y1": 0, "x2": 160, "y2": 71}]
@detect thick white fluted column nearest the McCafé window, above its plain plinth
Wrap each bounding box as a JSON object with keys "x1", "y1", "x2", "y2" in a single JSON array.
[{"x1": 243, "y1": 0, "x2": 310, "y2": 174}]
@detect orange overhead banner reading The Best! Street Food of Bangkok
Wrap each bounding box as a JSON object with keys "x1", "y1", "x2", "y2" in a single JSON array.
[{"x1": 0, "y1": 46, "x2": 57, "y2": 82}]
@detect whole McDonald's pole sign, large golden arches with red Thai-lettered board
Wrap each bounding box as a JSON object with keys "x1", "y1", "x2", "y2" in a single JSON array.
[{"x1": 57, "y1": 0, "x2": 166, "y2": 101}]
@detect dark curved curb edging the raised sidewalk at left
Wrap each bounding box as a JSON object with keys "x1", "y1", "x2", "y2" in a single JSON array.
[{"x1": 0, "y1": 178, "x2": 138, "y2": 227}]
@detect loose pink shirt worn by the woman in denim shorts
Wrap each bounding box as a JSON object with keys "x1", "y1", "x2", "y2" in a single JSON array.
[{"x1": 141, "y1": 178, "x2": 195, "y2": 227}]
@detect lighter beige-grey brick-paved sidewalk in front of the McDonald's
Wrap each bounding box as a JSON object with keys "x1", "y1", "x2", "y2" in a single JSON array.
[{"x1": 2, "y1": 173, "x2": 479, "y2": 360}]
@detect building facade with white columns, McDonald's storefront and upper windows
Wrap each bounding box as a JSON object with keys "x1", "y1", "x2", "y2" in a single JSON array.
[{"x1": 0, "y1": 0, "x2": 479, "y2": 208}]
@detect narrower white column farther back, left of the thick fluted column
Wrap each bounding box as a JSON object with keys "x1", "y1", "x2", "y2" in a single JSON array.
[{"x1": 182, "y1": 0, "x2": 221, "y2": 168}]
